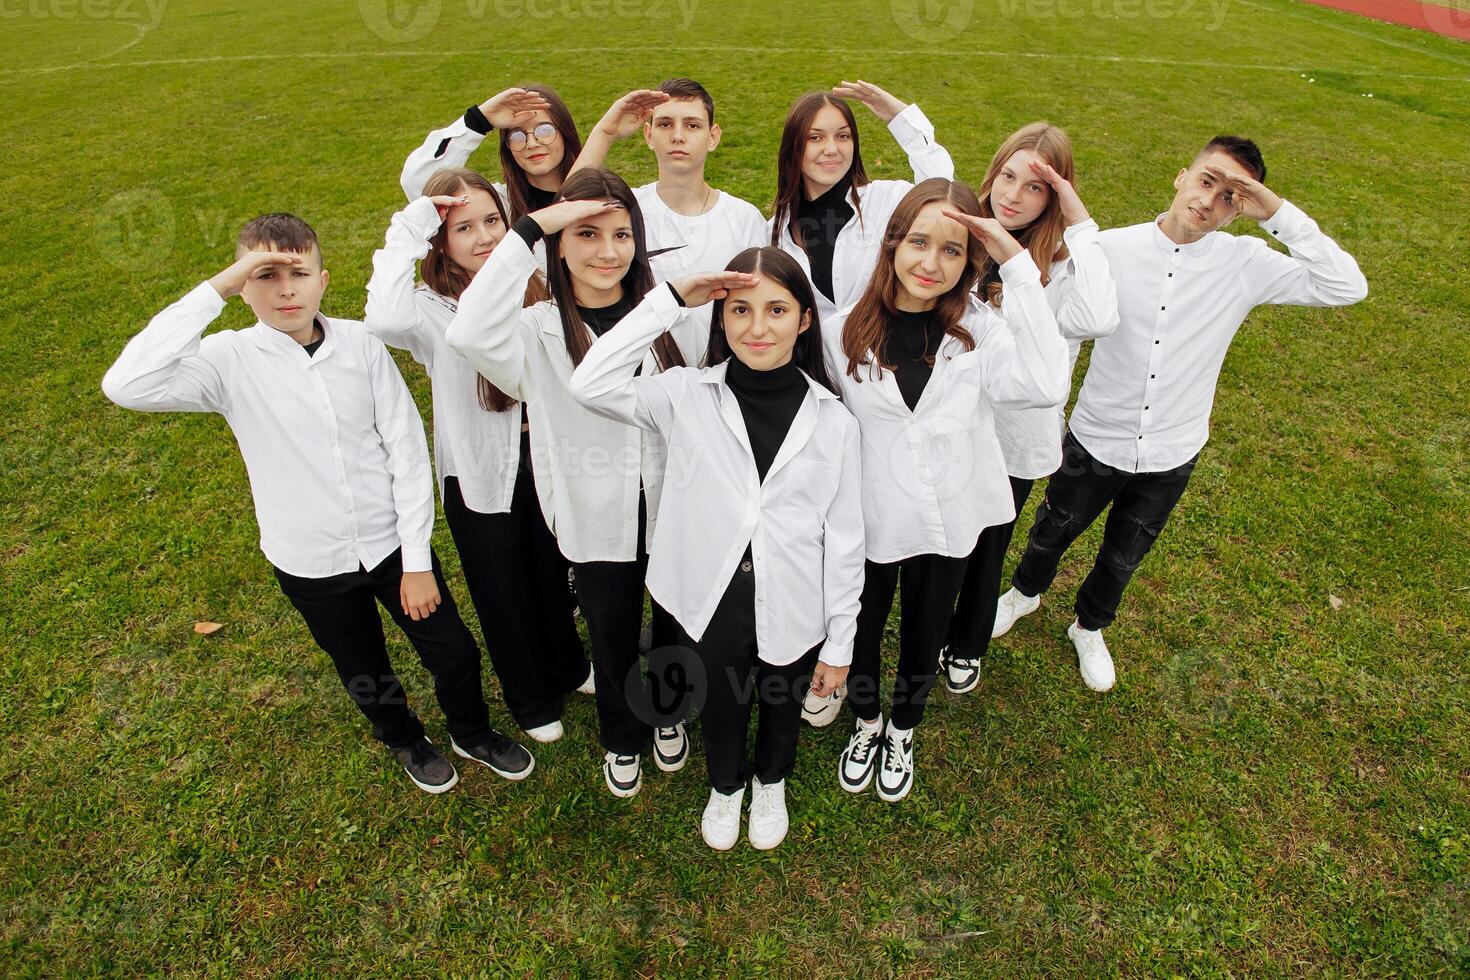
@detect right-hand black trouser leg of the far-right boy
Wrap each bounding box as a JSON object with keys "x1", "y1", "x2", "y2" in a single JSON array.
[{"x1": 1075, "y1": 455, "x2": 1200, "y2": 629}]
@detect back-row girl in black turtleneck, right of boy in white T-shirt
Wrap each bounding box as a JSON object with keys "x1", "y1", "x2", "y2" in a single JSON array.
[{"x1": 769, "y1": 81, "x2": 954, "y2": 326}]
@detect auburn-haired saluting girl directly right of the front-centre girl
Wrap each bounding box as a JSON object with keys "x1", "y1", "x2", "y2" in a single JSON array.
[{"x1": 825, "y1": 179, "x2": 1067, "y2": 801}]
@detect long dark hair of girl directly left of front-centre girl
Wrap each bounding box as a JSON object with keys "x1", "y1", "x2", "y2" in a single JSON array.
[{"x1": 545, "y1": 167, "x2": 684, "y2": 370}]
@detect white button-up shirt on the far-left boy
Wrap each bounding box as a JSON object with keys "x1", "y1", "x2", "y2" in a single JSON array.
[{"x1": 101, "y1": 282, "x2": 434, "y2": 579}]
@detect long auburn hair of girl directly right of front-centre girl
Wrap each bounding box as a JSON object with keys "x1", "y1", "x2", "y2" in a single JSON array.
[{"x1": 842, "y1": 176, "x2": 985, "y2": 382}]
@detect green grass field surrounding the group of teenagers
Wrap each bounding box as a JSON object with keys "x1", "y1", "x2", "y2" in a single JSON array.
[{"x1": 0, "y1": 0, "x2": 1470, "y2": 977}]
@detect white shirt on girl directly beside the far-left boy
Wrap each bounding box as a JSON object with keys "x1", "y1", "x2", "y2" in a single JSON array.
[{"x1": 363, "y1": 197, "x2": 520, "y2": 514}]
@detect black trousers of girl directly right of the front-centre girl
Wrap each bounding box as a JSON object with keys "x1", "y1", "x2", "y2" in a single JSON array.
[{"x1": 847, "y1": 555, "x2": 966, "y2": 729}]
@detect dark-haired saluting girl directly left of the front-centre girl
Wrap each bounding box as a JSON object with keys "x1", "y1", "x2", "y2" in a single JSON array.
[{"x1": 448, "y1": 169, "x2": 700, "y2": 796}]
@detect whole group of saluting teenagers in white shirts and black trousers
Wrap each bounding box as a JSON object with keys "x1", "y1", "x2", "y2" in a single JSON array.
[{"x1": 103, "y1": 78, "x2": 1367, "y2": 851}]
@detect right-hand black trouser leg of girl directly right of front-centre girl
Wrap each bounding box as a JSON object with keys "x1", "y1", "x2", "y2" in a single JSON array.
[{"x1": 892, "y1": 555, "x2": 966, "y2": 729}]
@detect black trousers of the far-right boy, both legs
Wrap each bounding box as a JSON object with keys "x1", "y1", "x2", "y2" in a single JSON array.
[{"x1": 1011, "y1": 432, "x2": 1200, "y2": 629}]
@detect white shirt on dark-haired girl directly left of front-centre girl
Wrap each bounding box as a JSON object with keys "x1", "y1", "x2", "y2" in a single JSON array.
[{"x1": 445, "y1": 231, "x2": 700, "y2": 563}]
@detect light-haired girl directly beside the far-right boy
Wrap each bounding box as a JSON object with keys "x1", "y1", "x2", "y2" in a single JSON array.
[{"x1": 941, "y1": 122, "x2": 1117, "y2": 693}]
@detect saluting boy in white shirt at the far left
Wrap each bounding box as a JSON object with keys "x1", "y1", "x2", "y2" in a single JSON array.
[{"x1": 101, "y1": 215, "x2": 535, "y2": 793}]
